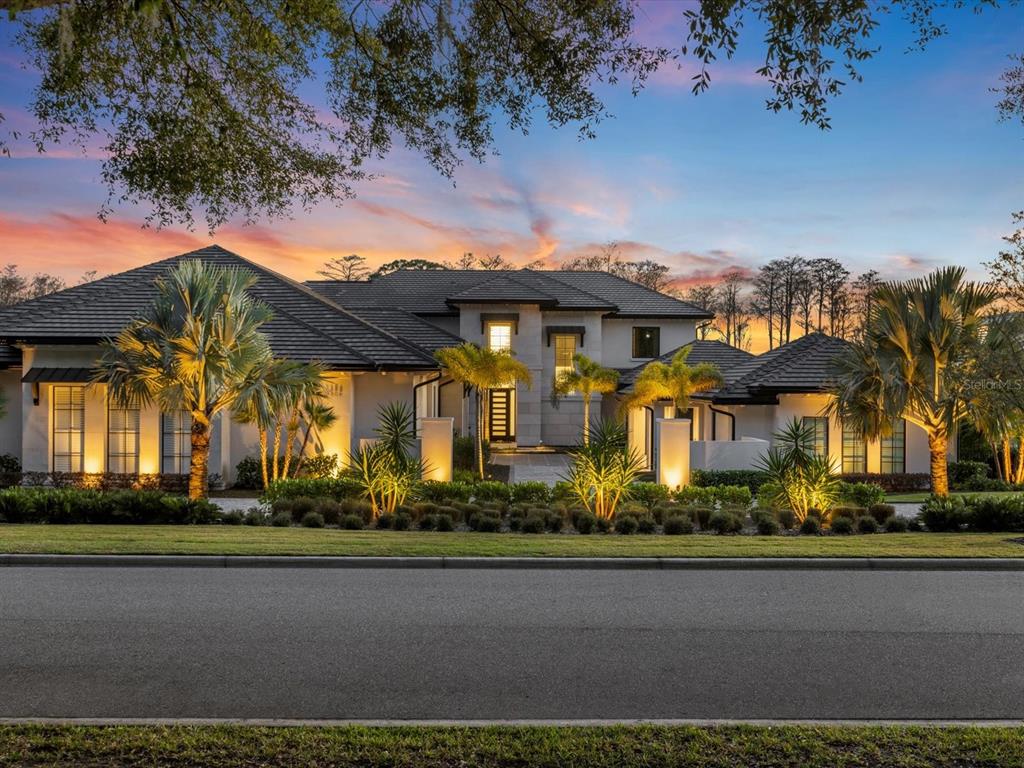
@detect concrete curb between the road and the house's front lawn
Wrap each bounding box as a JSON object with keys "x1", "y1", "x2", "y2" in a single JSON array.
[{"x1": 6, "y1": 555, "x2": 1024, "y2": 571}]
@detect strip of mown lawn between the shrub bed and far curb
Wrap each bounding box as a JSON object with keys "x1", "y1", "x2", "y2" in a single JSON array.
[{"x1": 0, "y1": 524, "x2": 1024, "y2": 557}]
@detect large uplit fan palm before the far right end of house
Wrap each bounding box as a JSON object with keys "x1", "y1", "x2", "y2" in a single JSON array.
[{"x1": 829, "y1": 266, "x2": 997, "y2": 496}]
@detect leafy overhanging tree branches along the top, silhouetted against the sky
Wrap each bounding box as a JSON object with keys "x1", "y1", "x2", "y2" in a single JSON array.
[{"x1": 0, "y1": 0, "x2": 1024, "y2": 230}]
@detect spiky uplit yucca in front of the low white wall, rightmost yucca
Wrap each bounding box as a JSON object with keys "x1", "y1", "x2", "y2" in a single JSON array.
[{"x1": 759, "y1": 417, "x2": 840, "y2": 522}]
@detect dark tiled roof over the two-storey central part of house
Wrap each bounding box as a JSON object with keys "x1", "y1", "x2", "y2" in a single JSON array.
[{"x1": 307, "y1": 269, "x2": 713, "y2": 319}]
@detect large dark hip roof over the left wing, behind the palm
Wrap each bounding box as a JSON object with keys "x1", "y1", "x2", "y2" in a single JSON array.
[{"x1": 0, "y1": 246, "x2": 437, "y2": 371}]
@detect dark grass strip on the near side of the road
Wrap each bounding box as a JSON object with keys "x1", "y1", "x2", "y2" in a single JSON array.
[{"x1": 0, "y1": 726, "x2": 1024, "y2": 768}]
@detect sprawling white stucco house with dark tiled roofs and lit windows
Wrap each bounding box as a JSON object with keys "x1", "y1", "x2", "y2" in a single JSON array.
[{"x1": 0, "y1": 246, "x2": 946, "y2": 483}]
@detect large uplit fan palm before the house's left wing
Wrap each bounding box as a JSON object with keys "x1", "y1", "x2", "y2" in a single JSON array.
[{"x1": 94, "y1": 260, "x2": 272, "y2": 499}]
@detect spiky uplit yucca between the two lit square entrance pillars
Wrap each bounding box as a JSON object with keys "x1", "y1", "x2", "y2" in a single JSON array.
[{"x1": 564, "y1": 420, "x2": 644, "y2": 520}]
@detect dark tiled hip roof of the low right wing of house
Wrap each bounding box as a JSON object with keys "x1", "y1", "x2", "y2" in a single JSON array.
[{"x1": 696, "y1": 333, "x2": 849, "y2": 403}]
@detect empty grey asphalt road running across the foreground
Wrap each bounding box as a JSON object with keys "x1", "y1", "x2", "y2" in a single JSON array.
[{"x1": 0, "y1": 567, "x2": 1024, "y2": 720}]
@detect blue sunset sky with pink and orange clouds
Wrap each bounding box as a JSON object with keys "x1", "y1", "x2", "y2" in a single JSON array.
[{"x1": 0, "y1": 0, "x2": 1024, "y2": 299}]
